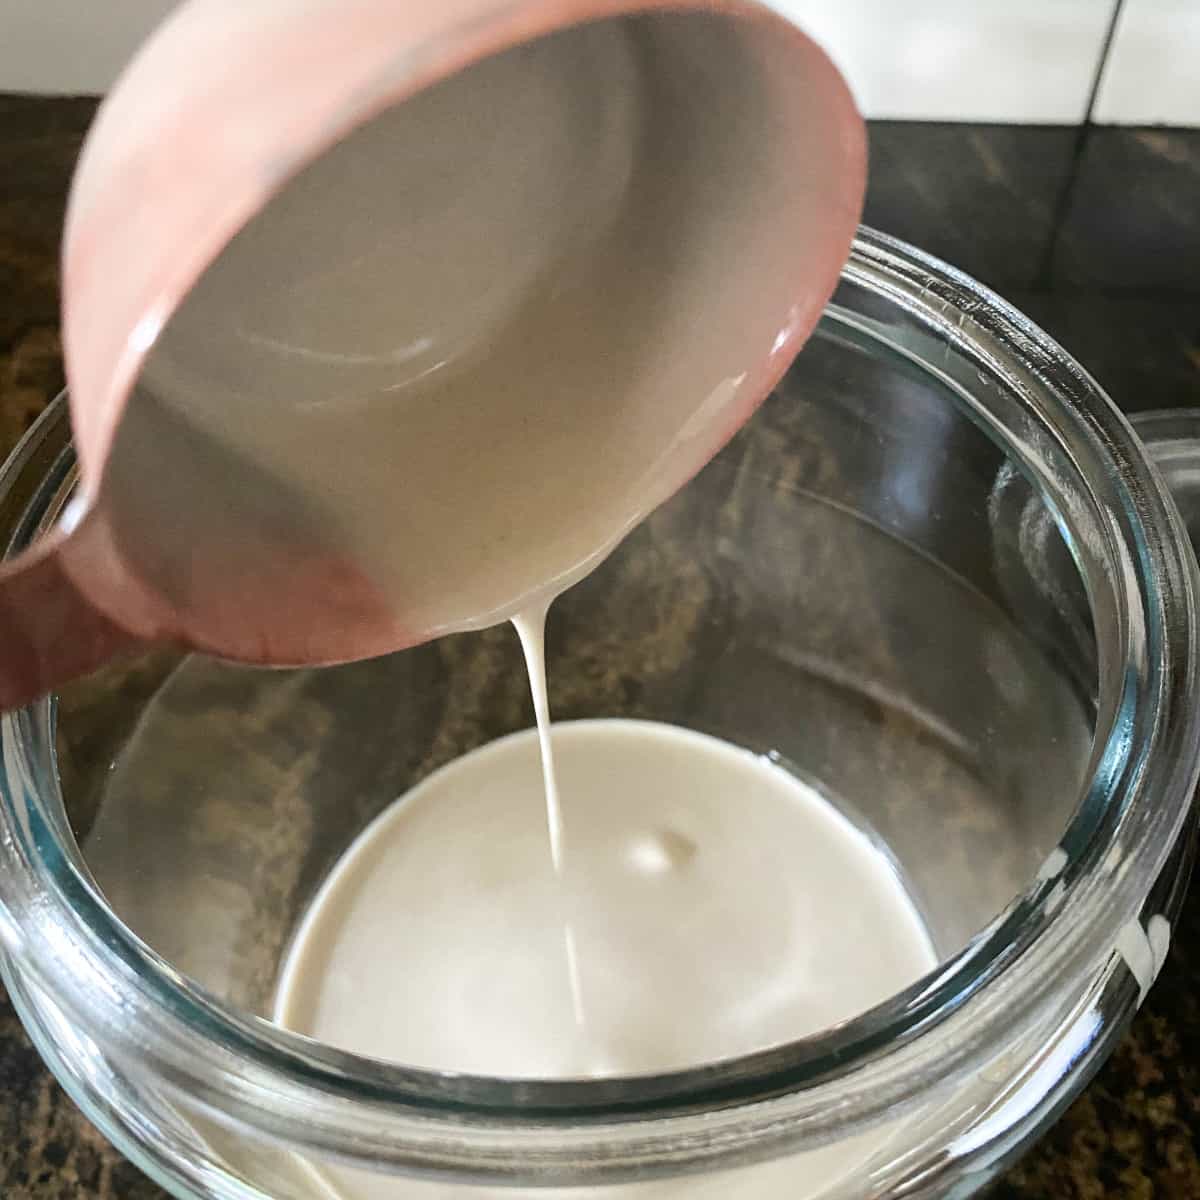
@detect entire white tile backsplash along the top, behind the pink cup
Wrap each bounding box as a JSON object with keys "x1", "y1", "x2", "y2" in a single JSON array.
[{"x1": 9, "y1": 0, "x2": 1200, "y2": 125}]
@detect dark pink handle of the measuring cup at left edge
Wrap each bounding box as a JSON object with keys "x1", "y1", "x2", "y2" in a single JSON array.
[{"x1": 0, "y1": 523, "x2": 154, "y2": 712}]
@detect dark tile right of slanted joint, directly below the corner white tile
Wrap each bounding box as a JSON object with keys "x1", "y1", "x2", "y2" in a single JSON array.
[{"x1": 1054, "y1": 128, "x2": 1200, "y2": 295}]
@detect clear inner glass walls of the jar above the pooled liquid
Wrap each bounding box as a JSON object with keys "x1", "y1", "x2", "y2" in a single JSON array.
[{"x1": 44, "y1": 286, "x2": 1098, "y2": 1067}]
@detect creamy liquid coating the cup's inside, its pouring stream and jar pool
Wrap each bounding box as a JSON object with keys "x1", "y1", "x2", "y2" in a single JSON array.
[{"x1": 103, "y1": 13, "x2": 934, "y2": 1200}]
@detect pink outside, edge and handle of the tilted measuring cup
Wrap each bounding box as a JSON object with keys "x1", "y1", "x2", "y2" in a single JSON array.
[{"x1": 0, "y1": 0, "x2": 865, "y2": 708}]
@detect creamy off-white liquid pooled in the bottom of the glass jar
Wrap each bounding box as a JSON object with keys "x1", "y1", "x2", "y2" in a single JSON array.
[{"x1": 275, "y1": 720, "x2": 936, "y2": 1200}]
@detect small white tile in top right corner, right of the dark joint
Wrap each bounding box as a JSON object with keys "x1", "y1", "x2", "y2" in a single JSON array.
[{"x1": 1093, "y1": 0, "x2": 1200, "y2": 126}]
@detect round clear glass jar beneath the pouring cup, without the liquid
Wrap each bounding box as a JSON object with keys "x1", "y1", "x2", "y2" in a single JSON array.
[{"x1": 0, "y1": 230, "x2": 1200, "y2": 1200}]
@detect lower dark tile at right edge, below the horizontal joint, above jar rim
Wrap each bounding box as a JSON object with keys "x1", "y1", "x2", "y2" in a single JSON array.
[{"x1": 1006, "y1": 289, "x2": 1200, "y2": 413}]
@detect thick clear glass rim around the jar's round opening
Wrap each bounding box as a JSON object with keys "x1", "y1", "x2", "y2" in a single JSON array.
[{"x1": 0, "y1": 229, "x2": 1200, "y2": 1182}]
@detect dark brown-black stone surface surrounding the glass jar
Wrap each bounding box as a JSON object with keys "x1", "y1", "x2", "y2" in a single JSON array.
[{"x1": 0, "y1": 96, "x2": 1200, "y2": 1200}]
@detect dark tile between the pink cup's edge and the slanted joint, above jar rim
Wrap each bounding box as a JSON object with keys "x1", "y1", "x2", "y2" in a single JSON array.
[{"x1": 864, "y1": 121, "x2": 1076, "y2": 287}]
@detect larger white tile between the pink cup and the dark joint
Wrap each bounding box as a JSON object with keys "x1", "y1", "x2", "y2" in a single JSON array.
[{"x1": 773, "y1": 0, "x2": 1113, "y2": 124}]
